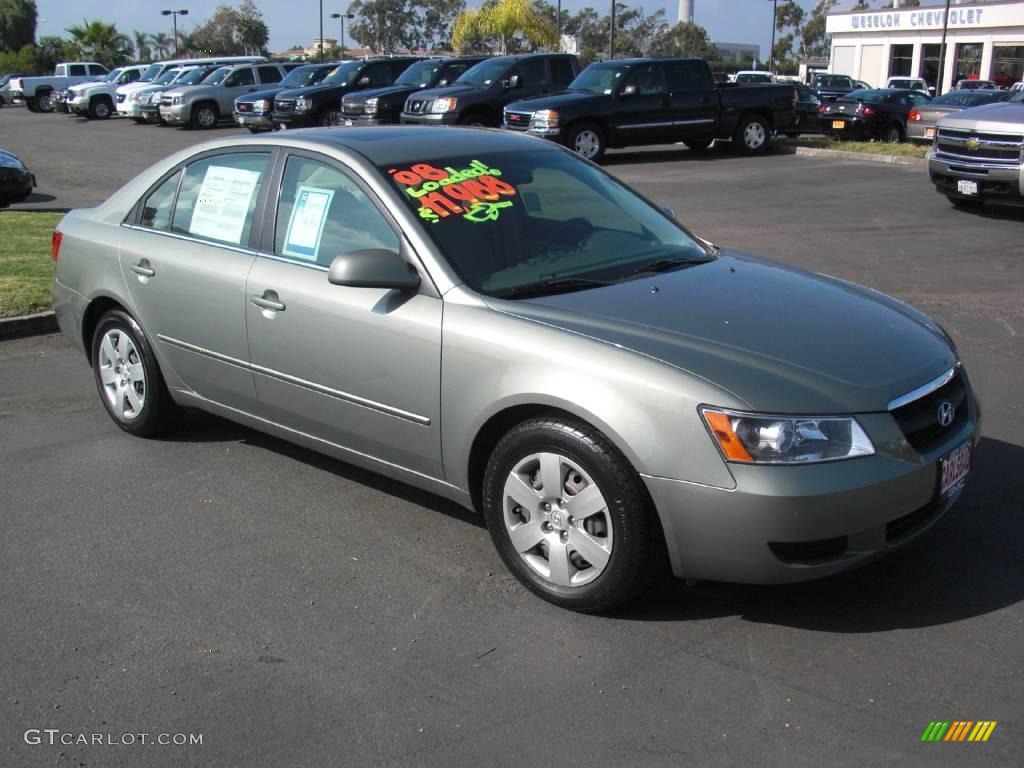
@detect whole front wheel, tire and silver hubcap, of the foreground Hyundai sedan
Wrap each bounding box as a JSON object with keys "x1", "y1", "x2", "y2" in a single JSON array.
[{"x1": 483, "y1": 416, "x2": 666, "y2": 612}]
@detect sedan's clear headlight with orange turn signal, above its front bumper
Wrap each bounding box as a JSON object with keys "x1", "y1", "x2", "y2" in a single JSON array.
[{"x1": 700, "y1": 407, "x2": 874, "y2": 464}]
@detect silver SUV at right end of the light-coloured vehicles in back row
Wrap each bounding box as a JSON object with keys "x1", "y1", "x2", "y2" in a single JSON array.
[{"x1": 160, "y1": 63, "x2": 299, "y2": 128}]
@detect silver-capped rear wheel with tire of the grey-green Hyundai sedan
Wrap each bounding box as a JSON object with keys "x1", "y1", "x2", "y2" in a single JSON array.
[{"x1": 92, "y1": 309, "x2": 175, "y2": 437}]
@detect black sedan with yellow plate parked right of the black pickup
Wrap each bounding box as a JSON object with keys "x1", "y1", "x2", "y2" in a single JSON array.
[{"x1": 818, "y1": 88, "x2": 932, "y2": 143}]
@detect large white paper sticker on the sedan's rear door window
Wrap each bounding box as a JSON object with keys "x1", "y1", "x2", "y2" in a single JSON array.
[{"x1": 188, "y1": 165, "x2": 260, "y2": 245}]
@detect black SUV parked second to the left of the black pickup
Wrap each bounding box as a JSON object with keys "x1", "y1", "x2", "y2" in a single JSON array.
[{"x1": 340, "y1": 56, "x2": 483, "y2": 125}]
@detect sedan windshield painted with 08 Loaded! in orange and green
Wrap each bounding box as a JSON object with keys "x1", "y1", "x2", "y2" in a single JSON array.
[{"x1": 380, "y1": 150, "x2": 710, "y2": 298}]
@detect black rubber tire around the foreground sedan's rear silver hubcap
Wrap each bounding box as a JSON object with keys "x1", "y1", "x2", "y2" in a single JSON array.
[{"x1": 90, "y1": 309, "x2": 177, "y2": 437}]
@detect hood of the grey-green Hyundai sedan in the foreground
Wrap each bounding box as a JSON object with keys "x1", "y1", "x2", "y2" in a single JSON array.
[{"x1": 485, "y1": 254, "x2": 956, "y2": 415}]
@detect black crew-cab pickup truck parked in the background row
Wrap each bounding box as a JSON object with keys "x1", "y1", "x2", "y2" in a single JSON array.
[{"x1": 504, "y1": 56, "x2": 796, "y2": 160}]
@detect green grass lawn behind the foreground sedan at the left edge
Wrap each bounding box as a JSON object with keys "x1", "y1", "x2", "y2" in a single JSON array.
[{"x1": 0, "y1": 211, "x2": 63, "y2": 317}]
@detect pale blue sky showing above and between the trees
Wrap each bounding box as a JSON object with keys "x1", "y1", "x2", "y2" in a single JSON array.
[{"x1": 36, "y1": 0, "x2": 950, "y2": 55}]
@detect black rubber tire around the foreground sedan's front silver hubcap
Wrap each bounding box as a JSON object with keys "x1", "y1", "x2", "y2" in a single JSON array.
[{"x1": 483, "y1": 415, "x2": 668, "y2": 612}]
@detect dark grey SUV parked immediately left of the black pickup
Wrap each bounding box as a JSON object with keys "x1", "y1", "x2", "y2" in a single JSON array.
[{"x1": 401, "y1": 53, "x2": 581, "y2": 127}]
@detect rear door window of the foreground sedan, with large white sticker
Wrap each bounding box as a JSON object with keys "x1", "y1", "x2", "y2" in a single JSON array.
[{"x1": 171, "y1": 153, "x2": 270, "y2": 245}]
